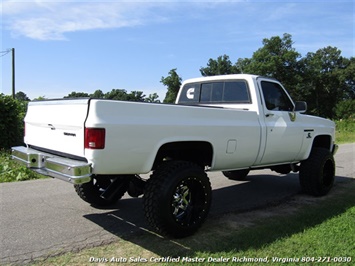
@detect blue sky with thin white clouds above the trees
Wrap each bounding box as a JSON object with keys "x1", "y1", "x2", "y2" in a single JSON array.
[{"x1": 0, "y1": 0, "x2": 355, "y2": 101}]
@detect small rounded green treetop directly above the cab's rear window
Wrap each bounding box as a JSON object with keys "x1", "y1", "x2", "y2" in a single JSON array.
[{"x1": 200, "y1": 55, "x2": 241, "y2": 77}]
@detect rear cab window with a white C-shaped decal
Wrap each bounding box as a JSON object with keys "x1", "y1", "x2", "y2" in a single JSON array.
[{"x1": 178, "y1": 80, "x2": 252, "y2": 105}]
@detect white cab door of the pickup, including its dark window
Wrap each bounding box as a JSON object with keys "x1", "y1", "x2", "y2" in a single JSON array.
[{"x1": 258, "y1": 79, "x2": 303, "y2": 165}]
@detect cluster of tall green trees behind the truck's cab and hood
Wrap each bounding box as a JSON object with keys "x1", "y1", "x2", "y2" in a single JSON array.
[{"x1": 200, "y1": 33, "x2": 355, "y2": 118}]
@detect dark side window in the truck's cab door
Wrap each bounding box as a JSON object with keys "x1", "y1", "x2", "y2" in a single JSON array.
[{"x1": 261, "y1": 81, "x2": 293, "y2": 111}]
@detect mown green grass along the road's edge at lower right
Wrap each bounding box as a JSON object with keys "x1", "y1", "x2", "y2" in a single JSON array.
[{"x1": 197, "y1": 186, "x2": 355, "y2": 265}]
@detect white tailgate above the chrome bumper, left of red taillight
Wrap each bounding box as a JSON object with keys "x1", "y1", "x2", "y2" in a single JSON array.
[{"x1": 25, "y1": 99, "x2": 90, "y2": 157}]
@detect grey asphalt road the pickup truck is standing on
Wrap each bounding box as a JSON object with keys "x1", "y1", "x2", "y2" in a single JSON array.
[{"x1": 0, "y1": 144, "x2": 355, "y2": 265}]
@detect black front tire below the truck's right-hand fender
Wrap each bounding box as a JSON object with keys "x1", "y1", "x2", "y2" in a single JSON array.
[{"x1": 299, "y1": 148, "x2": 335, "y2": 197}]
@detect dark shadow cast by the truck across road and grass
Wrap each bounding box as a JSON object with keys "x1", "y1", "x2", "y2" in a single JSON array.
[{"x1": 84, "y1": 174, "x2": 353, "y2": 259}]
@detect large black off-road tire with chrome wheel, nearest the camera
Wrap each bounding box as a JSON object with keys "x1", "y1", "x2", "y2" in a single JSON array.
[{"x1": 143, "y1": 161, "x2": 212, "y2": 238}]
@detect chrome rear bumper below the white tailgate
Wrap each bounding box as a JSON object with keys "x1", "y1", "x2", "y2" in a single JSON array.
[{"x1": 12, "y1": 146, "x2": 92, "y2": 184}]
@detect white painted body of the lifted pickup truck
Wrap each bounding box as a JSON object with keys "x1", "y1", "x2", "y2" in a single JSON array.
[{"x1": 25, "y1": 75, "x2": 335, "y2": 174}]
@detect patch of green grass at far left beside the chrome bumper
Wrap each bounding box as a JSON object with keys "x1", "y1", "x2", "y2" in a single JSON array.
[{"x1": 0, "y1": 150, "x2": 46, "y2": 183}]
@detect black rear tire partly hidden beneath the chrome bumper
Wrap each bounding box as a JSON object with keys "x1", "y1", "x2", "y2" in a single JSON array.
[{"x1": 74, "y1": 177, "x2": 129, "y2": 207}]
